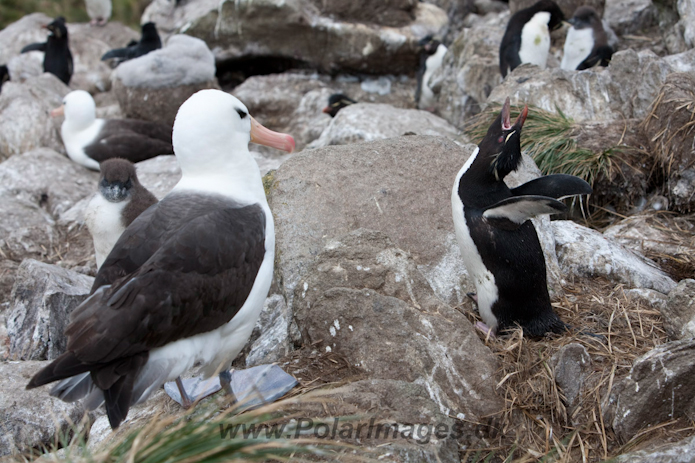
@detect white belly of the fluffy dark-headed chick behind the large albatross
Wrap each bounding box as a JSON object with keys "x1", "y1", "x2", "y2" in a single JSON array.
[{"x1": 84, "y1": 193, "x2": 129, "y2": 269}]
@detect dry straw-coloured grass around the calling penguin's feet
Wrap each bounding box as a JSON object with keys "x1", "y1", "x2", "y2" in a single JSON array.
[{"x1": 462, "y1": 282, "x2": 695, "y2": 463}]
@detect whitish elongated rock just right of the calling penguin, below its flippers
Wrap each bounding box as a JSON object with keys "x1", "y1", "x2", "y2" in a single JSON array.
[{"x1": 551, "y1": 220, "x2": 676, "y2": 294}]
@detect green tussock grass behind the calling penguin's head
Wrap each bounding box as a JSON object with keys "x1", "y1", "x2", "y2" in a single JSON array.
[{"x1": 465, "y1": 104, "x2": 620, "y2": 188}]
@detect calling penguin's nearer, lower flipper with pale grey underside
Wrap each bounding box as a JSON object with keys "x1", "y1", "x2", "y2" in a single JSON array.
[{"x1": 483, "y1": 195, "x2": 567, "y2": 230}]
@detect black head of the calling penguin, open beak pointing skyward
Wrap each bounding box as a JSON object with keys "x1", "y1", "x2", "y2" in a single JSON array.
[{"x1": 478, "y1": 98, "x2": 528, "y2": 181}]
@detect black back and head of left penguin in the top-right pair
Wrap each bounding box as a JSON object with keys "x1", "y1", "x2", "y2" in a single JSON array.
[{"x1": 499, "y1": 0, "x2": 565, "y2": 77}]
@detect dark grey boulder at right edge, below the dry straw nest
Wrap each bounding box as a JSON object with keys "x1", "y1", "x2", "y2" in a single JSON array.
[{"x1": 603, "y1": 339, "x2": 695, "y2": 442}]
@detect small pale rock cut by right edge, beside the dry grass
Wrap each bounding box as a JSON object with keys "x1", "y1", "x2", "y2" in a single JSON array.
[{"x1": 661, "y1": 279, "x2": 695, "y2": 339}]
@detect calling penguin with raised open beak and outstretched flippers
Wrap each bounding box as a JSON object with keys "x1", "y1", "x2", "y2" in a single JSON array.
[{"x1": 451, "y1": 98, "x2": 591, "y2": 337}]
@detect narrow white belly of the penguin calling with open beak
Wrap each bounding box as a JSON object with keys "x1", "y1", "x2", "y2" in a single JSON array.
[{"x1": 451, "y1": 148, "x2": 499, "y2": 332}]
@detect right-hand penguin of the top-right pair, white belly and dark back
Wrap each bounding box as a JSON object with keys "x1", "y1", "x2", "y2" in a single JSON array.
[{"x1": 560, "y1": 6, "x2": 613, "y2": 71}]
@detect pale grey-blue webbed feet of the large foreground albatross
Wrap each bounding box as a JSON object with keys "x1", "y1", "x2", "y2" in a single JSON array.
[{"x1": 164, "y1": 365, "x2": 297, "y2": 409}]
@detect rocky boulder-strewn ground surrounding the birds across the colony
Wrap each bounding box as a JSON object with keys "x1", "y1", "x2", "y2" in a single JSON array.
[{"x1": 0, "y1": 0, "x2": 695, "y2": 462}]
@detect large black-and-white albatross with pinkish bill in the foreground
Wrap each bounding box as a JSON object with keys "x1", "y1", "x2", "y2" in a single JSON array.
[{"x1": 27, "y1": 90, "x2": 294, "y2": 428}]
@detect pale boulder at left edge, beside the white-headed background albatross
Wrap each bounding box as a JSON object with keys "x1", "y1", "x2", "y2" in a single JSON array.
[{"x1": 0, "y1": 73, "x2": 70, "y2": 161}]
